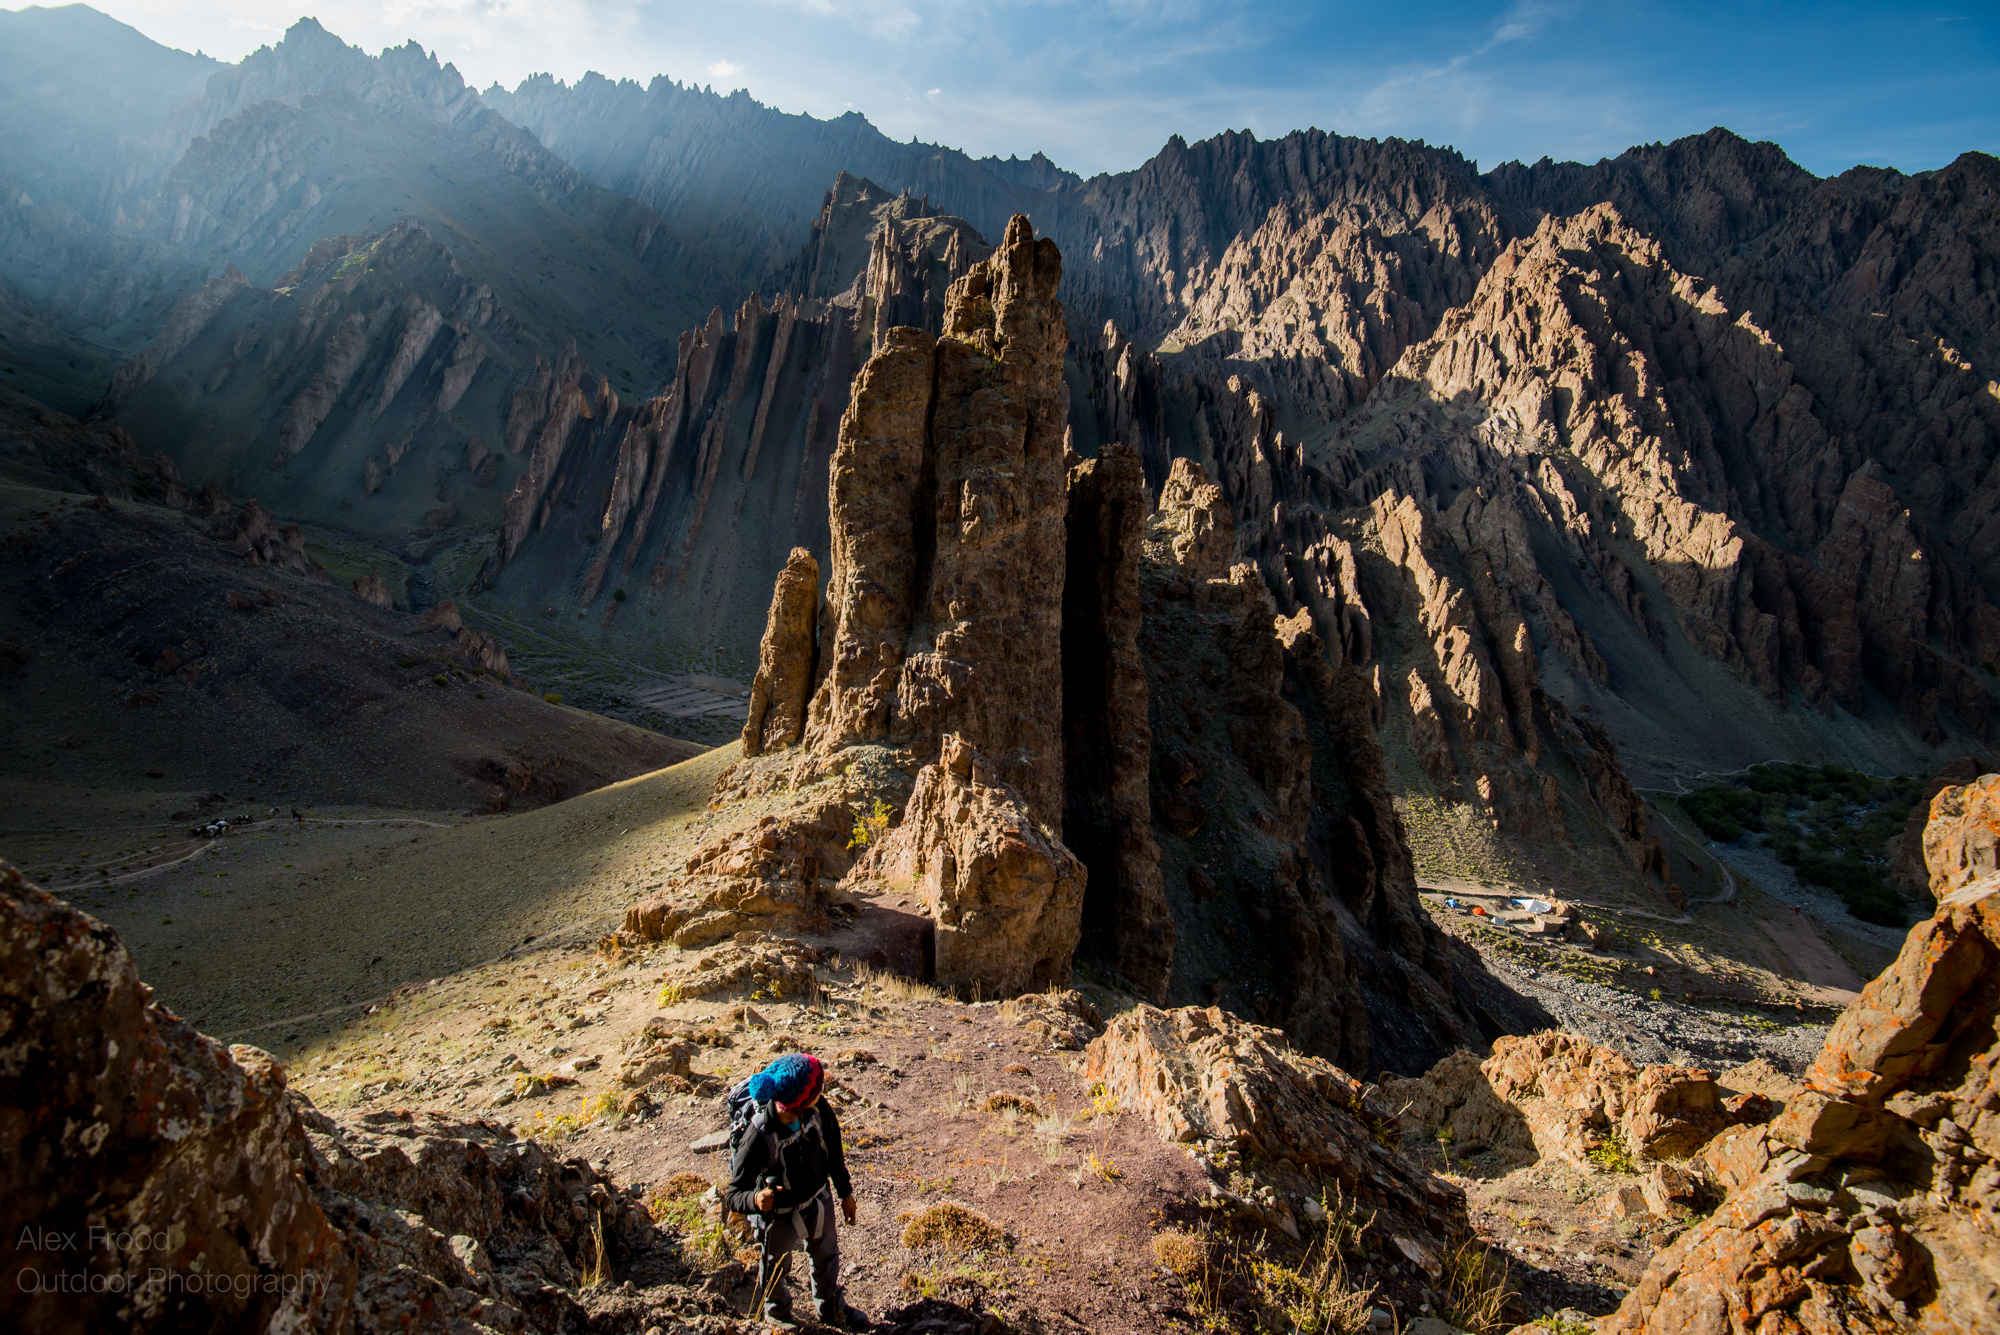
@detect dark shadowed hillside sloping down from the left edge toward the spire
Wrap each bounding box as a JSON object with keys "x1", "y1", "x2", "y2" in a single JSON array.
[{"x1": 0, "y1": 379, "x2": 692, "y2": 829}]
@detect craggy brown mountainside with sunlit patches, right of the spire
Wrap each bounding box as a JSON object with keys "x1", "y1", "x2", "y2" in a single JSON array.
[{"x1": 1058, "y1": 132, "x2": 1996, "y2": 877}]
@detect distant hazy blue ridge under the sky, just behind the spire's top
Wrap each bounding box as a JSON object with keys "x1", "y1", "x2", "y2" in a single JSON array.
[{"x1": 480, "y1": 74, "x2": 1078, "y2": 285}]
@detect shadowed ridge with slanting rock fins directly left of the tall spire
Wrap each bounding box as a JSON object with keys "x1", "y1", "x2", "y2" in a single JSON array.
[{"x1": 482, "y1": 176, "x2": 990, "y2": 666}]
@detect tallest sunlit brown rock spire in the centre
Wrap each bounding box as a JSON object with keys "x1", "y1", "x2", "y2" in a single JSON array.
[{"x1": 806, "y1": 218, "x2": 1068, "y2": 825}]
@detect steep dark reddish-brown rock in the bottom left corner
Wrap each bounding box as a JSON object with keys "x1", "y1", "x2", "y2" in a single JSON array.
[{"x1": 0, "y1": 865, "x2": 358, "y2": 1333}]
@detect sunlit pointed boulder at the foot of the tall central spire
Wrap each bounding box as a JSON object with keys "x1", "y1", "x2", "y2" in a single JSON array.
[{"x1": 842, "y1": 733, "x2": 1084, "y2": 995}]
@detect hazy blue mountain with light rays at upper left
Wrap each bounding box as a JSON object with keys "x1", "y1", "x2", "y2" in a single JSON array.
[{"x1": 58, "y1": 20, "x2": 772, "y2": 568}]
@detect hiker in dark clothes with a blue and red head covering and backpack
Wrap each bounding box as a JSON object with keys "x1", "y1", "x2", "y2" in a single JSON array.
[{"x1": 724, "y1": 1053, "x2": 870, "y2": 1331}]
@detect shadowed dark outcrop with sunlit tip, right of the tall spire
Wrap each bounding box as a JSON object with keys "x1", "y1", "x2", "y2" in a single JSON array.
[{"x1": 1140, "y1": 460, "x2": 1504, "y2": 1073}]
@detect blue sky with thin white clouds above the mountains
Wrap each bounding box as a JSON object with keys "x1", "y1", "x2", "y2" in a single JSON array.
[{"x1": 43, "y1": 0, "x2": 2000, "y2": 174}]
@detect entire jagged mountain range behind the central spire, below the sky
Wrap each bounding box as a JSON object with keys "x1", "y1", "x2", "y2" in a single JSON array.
[{"x1": 0, "y1": 6, "x2": 2000, "y2": 883}]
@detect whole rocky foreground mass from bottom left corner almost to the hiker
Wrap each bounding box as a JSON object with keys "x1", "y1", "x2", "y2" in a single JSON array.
[{"x1": 0, "y1": 863, "x2": 696, "y2": 1335}]
